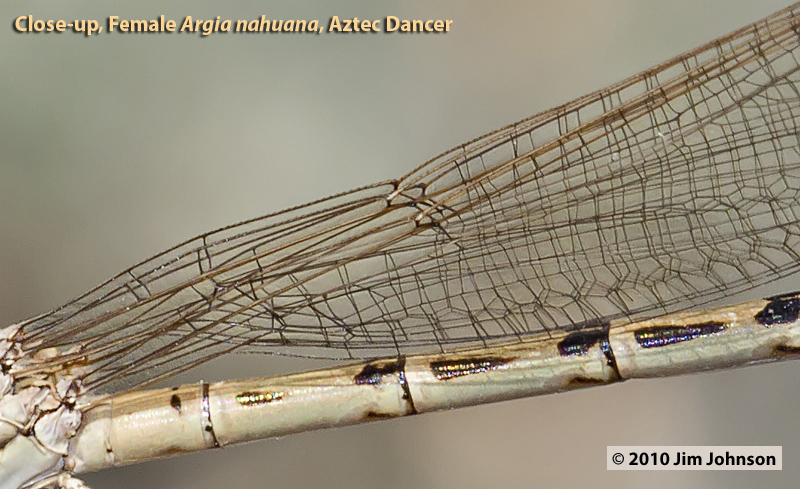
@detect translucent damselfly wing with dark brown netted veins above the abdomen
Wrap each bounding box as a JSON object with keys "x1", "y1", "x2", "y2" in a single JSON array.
[{"x1": 10, "y1": 1, "x2": 800, "y2": 392}]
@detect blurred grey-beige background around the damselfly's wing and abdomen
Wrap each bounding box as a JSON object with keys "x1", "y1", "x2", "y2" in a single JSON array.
[{"x1": 0, "y1": 0, "x2": 800, "y2": 489}]
